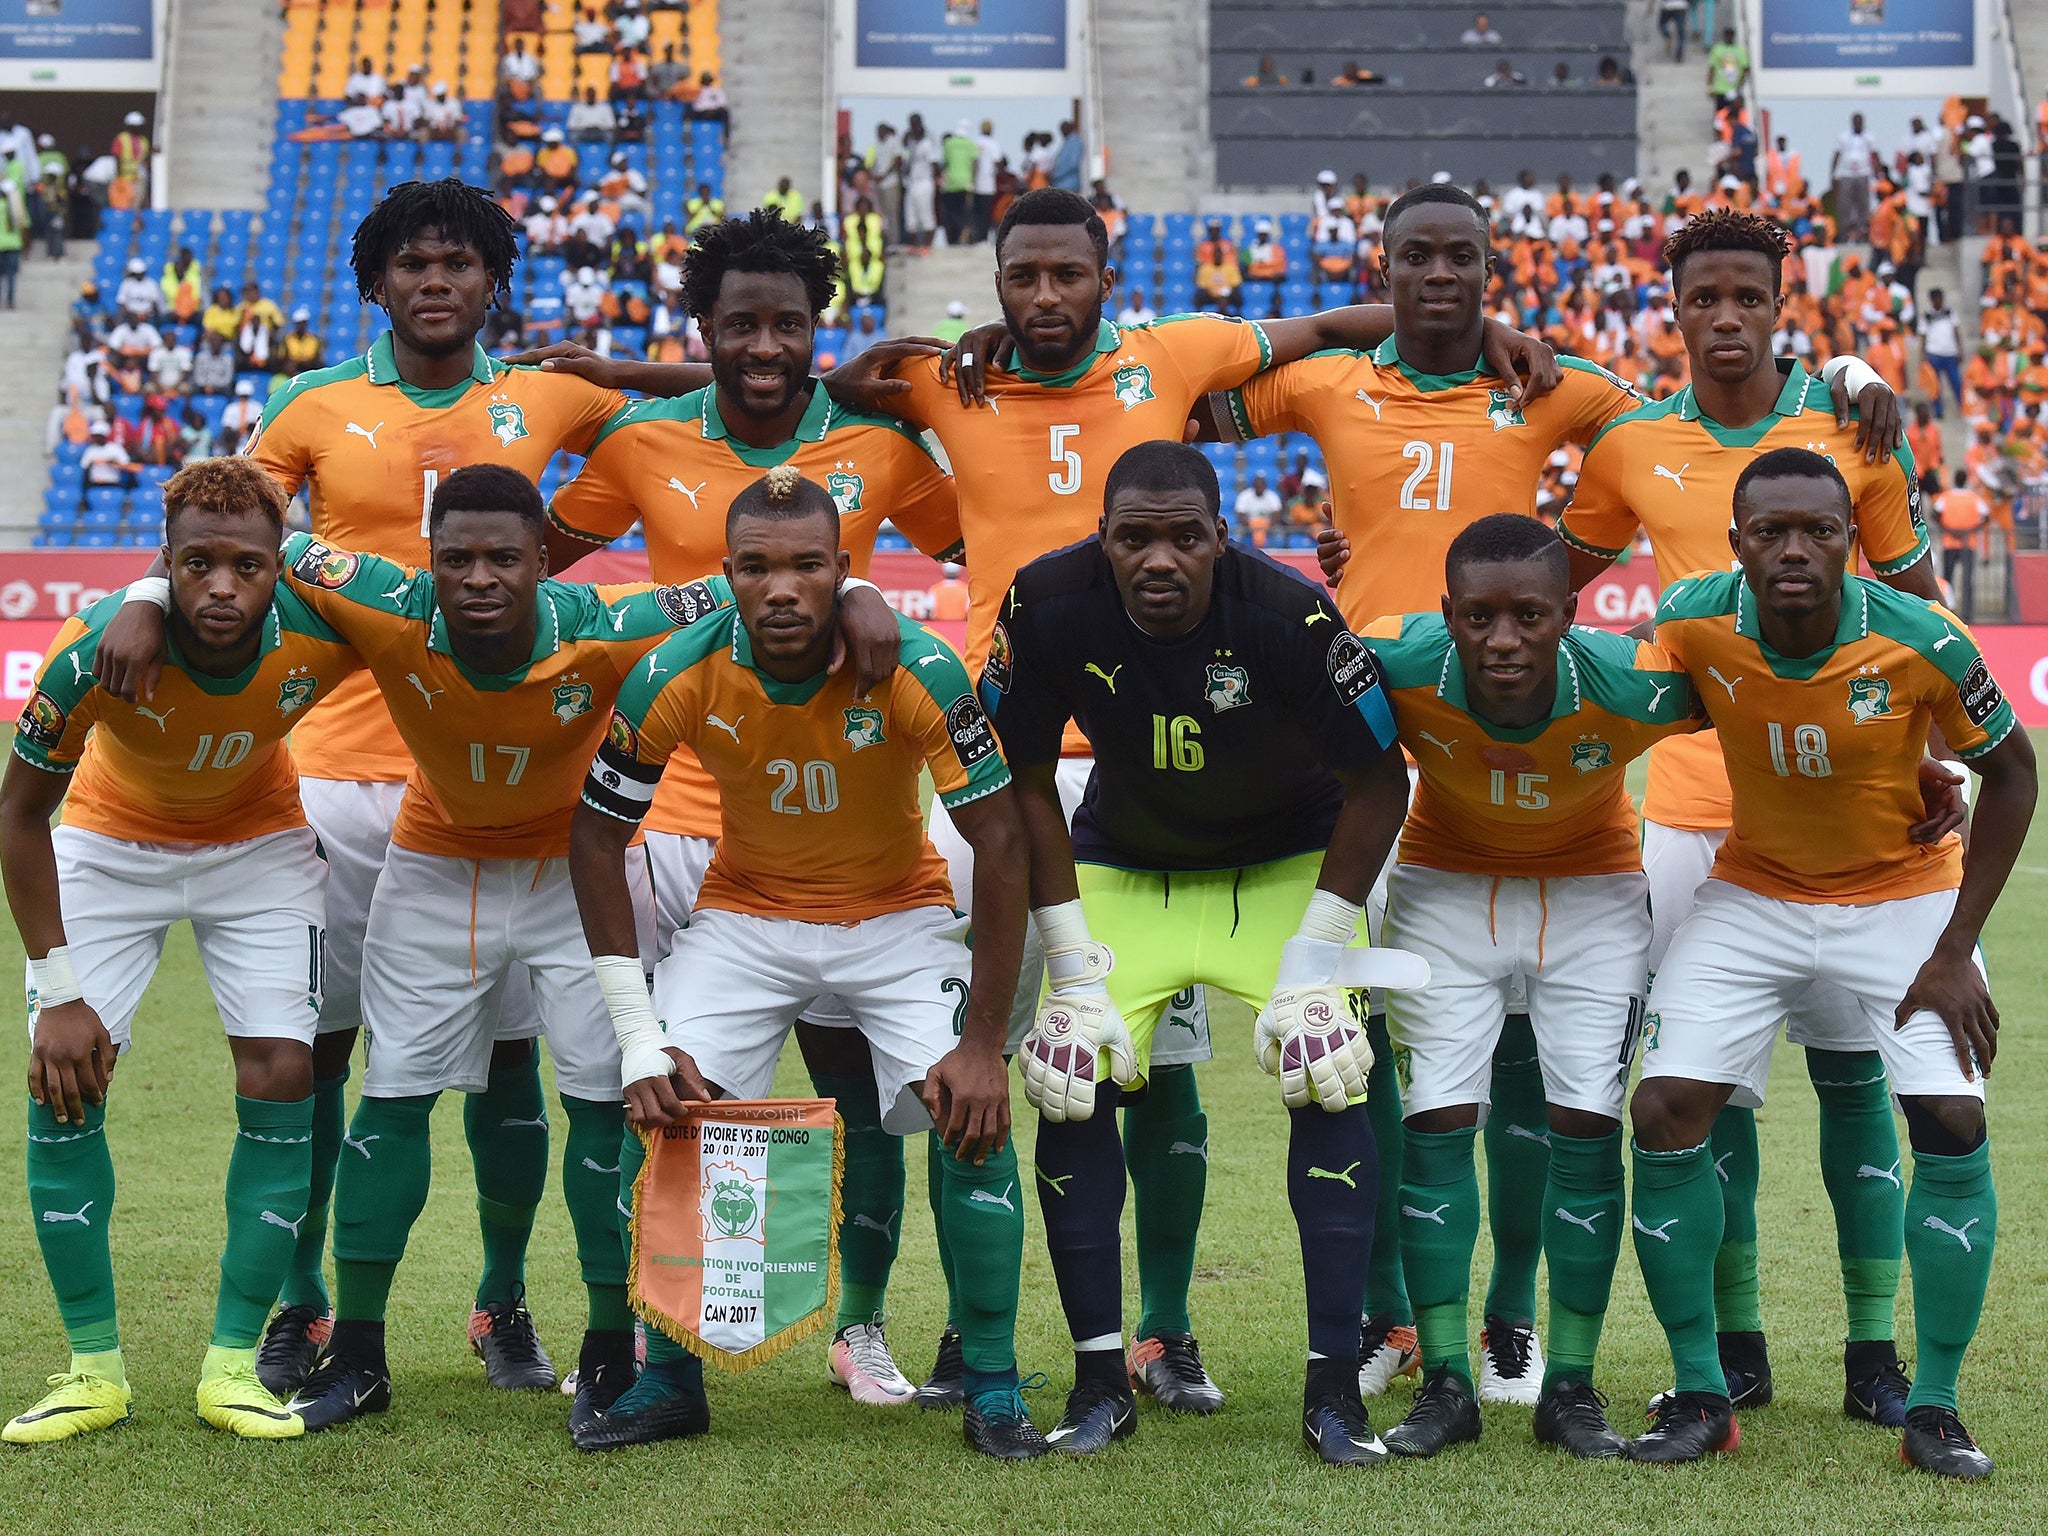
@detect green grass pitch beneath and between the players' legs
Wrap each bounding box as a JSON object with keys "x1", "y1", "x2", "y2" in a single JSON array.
[{"x1": 0, "y1": 741, "x2": 2048, "y2": 1536}]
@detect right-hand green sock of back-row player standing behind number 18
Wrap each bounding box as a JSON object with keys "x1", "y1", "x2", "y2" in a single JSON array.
[{"x1": 1806, "y1": 1051, "x2": 1907, "y2": 1341}]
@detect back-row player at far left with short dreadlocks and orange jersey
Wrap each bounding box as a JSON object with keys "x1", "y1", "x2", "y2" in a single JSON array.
[{"x1": 98, "y1": 178, "x2": 633, "y2": 1407}]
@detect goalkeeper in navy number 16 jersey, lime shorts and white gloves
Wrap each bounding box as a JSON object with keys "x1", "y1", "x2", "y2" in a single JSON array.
[{"x1": 981, "y1": 442, "x2": 1419, "y2": 1464}]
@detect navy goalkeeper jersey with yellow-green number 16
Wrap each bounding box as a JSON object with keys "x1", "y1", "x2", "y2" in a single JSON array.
[{"x1": 981, "y1": 539, "x2": 1395, "y2": 870}]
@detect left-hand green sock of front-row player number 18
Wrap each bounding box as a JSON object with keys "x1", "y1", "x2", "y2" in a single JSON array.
[{"x1": 1630, "y1": 1143, "x2": 1729, "y2": 1397}]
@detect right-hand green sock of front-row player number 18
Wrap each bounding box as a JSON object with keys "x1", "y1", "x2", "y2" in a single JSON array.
[{"x1": 1907, "y1": 1141, "x2": 1999, "y2": 1409}]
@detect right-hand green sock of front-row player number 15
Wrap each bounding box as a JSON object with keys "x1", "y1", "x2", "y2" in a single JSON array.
[{"x1": 1542, "y1": 1130, "x2": 1628, "y2": 1391}]
